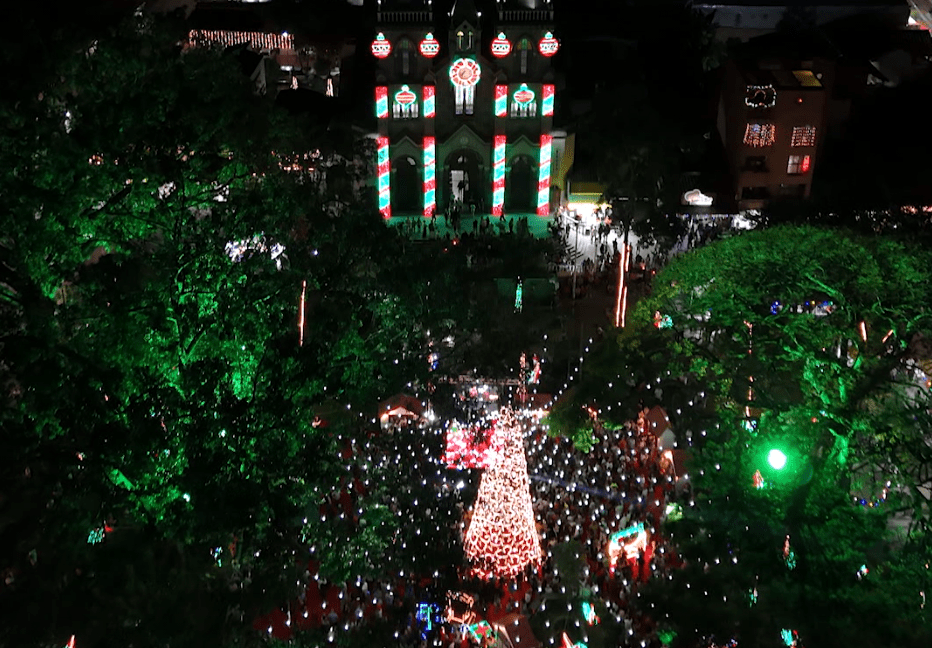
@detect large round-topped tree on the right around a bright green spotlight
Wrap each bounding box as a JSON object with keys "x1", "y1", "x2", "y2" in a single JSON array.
[{"x1": 548, "y1": 228, "x2": 932, "y2": 646}]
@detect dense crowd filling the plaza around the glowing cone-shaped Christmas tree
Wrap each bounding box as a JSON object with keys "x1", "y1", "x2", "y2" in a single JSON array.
[{"x1": 249, "y1": 402, "x2": 679, "y2": 648}]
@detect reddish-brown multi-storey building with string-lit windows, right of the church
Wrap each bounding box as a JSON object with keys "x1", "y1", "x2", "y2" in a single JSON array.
[{"x1": 717, "y1": 5, "x2": 932, "y2": 210}]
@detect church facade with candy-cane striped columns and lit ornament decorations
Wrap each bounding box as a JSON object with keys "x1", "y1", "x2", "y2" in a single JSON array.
[{"x1": 371, "y1": 0, "x2": 566, "y2": 218}]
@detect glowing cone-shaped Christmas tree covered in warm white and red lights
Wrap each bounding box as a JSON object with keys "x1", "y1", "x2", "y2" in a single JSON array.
[{"x1": 464, "y1": 409, "x2": 541, "y2": 579}]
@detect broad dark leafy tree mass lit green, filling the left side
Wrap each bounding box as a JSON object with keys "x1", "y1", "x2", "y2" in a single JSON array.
[{"x1": 0, "y1": 10, "x2": 474, "y2": 646}]
